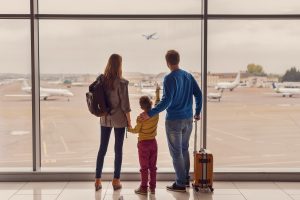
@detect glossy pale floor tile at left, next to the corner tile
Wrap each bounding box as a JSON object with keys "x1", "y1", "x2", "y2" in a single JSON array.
[{"x1": 17, "y1": 182, "x2": 67, "y2": 195}]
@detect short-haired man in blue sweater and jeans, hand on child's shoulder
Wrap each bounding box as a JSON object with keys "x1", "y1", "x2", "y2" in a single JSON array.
[{"x1": 140, "y1": 50, "x2": 202, "y2": 192}]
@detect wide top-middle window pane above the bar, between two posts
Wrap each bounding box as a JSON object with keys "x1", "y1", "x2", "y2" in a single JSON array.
[{"x1": 39, "y1": 0, "x2": 201, "y2": 15}]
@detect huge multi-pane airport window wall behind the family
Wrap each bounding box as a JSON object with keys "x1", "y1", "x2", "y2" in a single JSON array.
[{"x1": 0, "y1": 0, "x2": 300, "y2": 179}]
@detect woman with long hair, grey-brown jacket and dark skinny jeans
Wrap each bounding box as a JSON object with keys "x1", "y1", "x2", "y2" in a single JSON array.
[{"x1": 95, "y1": 54, "x2": 131, "y2": 191}]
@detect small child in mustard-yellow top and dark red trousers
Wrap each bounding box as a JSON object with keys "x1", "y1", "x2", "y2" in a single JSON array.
[{"x1": 128, "y1": 96, "x2": 159, "y2": 195}]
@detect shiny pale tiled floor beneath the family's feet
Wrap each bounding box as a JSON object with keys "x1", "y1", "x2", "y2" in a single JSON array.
[{"x1": 0, "y1": 182, "x2": 300, "y2": 200}]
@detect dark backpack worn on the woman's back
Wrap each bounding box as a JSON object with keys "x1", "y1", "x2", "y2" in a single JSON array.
[{"x1": 86, "y1": 74, "x2": 110, "y2": 117}]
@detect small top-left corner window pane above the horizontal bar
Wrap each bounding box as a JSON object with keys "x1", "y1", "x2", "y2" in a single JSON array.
[{"x1": 0, "y1": 0, "x2": 30, "y2": 14}]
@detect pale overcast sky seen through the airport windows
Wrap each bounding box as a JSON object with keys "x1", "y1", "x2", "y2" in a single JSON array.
[{"x1": 0, "y1": 0, "x2": 300, "y2": 74}]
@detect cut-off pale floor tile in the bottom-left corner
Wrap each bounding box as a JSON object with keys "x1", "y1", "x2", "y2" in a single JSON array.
[{"x1": 0, "y1": 182, "x2": 26, "y2": 200}]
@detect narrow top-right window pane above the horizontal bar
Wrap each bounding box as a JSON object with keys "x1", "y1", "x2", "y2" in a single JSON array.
[{"x1": 208, "y1": 0, "x2": 300, "y2": 15}]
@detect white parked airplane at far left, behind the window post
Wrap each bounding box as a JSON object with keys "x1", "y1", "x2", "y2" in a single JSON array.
[{"x1": 5, "y1": 81, "x2": 74, "y2": 101}]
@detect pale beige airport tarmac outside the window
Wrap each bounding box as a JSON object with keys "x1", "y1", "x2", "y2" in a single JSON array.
[{"x1": 0, "y1": 83, "x2": 300, "y2": 169}]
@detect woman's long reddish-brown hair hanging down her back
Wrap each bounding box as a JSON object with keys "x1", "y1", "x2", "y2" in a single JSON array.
[{"x1": 104, "y1": 54, "x2": 122, "y2": 90}]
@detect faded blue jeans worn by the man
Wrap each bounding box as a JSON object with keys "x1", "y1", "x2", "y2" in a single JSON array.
[{"x1": 166, "y1": 118, "x2": 193, "y2": 187}]
